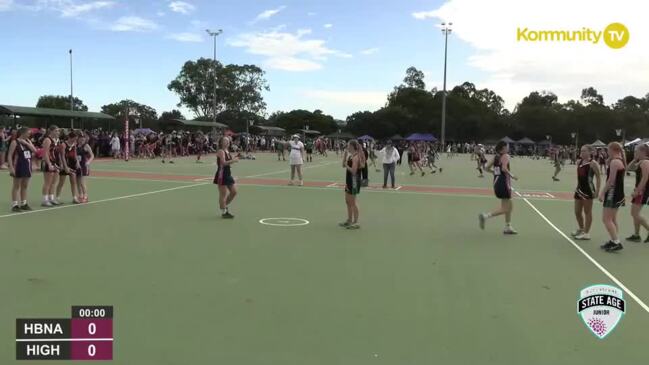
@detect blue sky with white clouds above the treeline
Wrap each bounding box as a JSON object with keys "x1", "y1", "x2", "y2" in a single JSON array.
[{"x1": 0, "y1": 0, "x2": 649, "y2": 119}]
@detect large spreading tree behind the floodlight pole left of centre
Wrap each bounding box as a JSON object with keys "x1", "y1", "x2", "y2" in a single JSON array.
[{"x1": 167, "y1": 58, "x2": 269, "y2": 117}]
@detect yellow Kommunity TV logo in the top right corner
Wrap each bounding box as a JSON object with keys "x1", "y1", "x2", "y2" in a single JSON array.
[{"x1": 516, "y1": 23, "x2": 630, "y2": 49}]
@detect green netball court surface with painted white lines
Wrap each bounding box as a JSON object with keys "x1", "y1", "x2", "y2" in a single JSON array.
[{"x1": 0, "y1": 154, "x2": 649, "y2": 365}]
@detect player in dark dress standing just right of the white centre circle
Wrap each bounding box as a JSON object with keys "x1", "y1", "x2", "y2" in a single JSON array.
[{"x1": 340, "y1": 140, "x2": 366, "y2": 229}]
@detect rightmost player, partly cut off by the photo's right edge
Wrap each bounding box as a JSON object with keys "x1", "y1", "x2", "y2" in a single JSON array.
[{"x1": 626, "y1": 144, "x2": 649, "y2": 242}]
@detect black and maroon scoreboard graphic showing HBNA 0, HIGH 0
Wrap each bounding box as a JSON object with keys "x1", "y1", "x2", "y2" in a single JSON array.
[{"x1": 16, "y1": 306, "x2": 114, "y2": 361}]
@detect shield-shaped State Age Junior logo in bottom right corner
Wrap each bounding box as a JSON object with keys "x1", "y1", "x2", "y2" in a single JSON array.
[{"x1": 577, "y1": 284, "x2": 626, "y2": 340}]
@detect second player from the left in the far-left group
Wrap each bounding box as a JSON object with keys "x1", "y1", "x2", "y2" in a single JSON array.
[{"x1": 41, "y1": 125, "x2": 61, "y2": 207}]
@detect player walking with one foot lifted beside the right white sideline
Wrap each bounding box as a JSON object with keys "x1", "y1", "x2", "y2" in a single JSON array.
[{"x1": 478, "y1": 141, "x2": 518, "y2": 235}]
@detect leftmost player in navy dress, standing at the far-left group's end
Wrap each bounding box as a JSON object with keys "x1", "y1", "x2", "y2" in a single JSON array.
[{"x1": 7, "y1": 127, "x2": 36, "y2": 212}]
